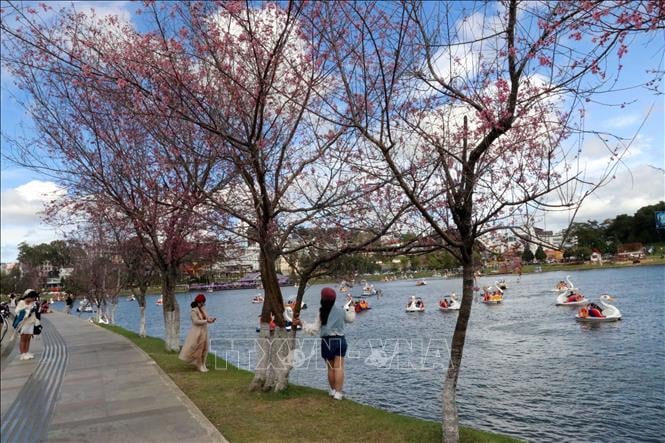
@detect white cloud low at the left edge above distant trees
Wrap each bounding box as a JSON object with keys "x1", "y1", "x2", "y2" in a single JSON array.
[{"x1": 0, "y1": 180, "x2": 64, "y2": 262}]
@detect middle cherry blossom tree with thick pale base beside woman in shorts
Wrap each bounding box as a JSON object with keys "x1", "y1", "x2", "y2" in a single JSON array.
[{"x1": 91, "y1": 1, "x2": 412, "y2": 390}]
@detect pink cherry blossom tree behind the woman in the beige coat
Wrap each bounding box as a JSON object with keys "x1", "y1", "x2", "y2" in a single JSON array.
[{"x1": 2, "y1": 4, "x2": 226, "y2": 350}]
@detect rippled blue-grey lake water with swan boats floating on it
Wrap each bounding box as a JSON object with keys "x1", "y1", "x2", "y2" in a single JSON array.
[{"x1": 56, "y1": 266, "x2": 665, "y2": 441}]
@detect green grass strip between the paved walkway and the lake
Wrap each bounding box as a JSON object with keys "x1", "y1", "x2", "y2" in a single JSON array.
[{"x1": 105, "y1": 326, "x2": 517, "y2": 443}]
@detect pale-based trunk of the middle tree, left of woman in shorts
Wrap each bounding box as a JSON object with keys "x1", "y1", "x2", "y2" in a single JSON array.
[{"x1": 249, "y1": 247, "x2": 288, "y2": 391}]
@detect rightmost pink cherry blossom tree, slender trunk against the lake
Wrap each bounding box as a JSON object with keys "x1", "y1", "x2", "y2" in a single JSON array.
[{"x1": 315, "y1": 0, "x2": 664, "y2": 442}]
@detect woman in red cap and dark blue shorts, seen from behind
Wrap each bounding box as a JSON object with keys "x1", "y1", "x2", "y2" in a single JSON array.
[{"x1": 294, "y1": 288, "x2": 356, "y2": 400}]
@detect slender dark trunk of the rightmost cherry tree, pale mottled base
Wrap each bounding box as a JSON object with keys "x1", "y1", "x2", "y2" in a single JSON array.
[{"x1": 441, "y1": 248, "x2": 474, "y2": 443}]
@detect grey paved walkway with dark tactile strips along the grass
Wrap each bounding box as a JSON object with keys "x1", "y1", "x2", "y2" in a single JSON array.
[{"x1": 0, "y1": 313, "x2": 226, "y2": 443}]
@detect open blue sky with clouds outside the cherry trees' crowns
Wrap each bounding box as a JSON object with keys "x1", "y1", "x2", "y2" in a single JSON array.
[{"x1": 0, "y1": 1, "x2": 665, "y2": 262}]
